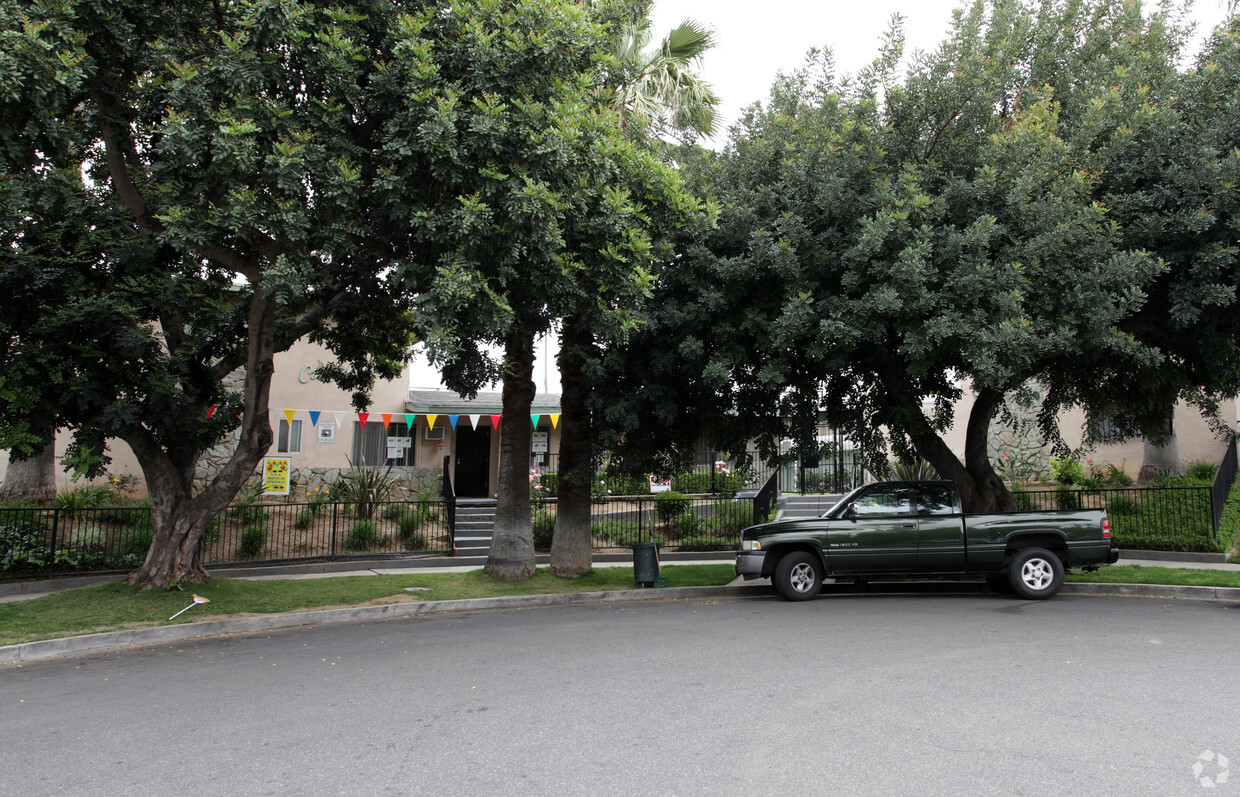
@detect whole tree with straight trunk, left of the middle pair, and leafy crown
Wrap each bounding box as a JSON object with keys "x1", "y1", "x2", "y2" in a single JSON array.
[{"x1": 414, "y1": 4, "x2": 709, "y2": 579}]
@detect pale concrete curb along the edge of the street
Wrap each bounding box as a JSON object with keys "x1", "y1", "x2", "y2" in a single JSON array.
[{"x1": 0, "y1": 584, "x2": 1240, "y2": 664}]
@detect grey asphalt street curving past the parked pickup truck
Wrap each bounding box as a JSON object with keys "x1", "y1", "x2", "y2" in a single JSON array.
[{"x1": 0, "y1": 592, "x2": 1240, "y2": 797}]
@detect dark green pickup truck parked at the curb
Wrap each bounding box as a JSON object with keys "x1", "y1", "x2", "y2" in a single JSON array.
[{"x1": 737, "y1": 481, "x2": 1120, "y2": 600}]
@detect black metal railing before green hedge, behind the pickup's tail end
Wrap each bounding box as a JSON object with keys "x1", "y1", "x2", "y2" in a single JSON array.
[{"x1": 1016, "y1": 487, "x2": 1219, "y2": 552}]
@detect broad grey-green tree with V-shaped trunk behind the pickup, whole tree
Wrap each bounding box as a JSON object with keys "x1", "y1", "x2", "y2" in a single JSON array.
[{"x1": 602, "y1": 1, "x2": 1230, "y2": 511}]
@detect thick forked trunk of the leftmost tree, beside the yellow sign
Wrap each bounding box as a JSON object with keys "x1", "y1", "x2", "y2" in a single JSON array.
[{"x1": 123, "y1": 288, "x2": 275, "y2": 589}]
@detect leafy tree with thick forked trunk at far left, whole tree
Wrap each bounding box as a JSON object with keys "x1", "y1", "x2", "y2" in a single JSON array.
[{"x1": 0, "y1": 0, "x2": 639, "y2": 585}]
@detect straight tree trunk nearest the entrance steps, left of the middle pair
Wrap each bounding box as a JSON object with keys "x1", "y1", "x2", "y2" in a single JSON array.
[{"x1": 484, "y1": 332, "x2": 534, "y2": 581}]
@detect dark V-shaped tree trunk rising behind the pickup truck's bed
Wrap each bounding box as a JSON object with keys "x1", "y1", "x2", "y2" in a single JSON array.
[{"x1": 903, "y1": 390, "x2": 1017, "y2": 514}]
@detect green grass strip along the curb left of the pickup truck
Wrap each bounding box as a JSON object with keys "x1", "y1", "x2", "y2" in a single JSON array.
[{"x1": 0, "y1": 563, "x2": 735, "y2": 646}]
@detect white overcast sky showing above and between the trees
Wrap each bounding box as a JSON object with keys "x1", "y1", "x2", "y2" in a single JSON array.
[{"x1": 409, "y1": 0, "x2": 1224, "y2": 394}]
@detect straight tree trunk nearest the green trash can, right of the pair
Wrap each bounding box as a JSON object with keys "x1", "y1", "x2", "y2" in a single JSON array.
[{"x1": 551, "y1": 319, "x2": 594, "y2": 579}]
